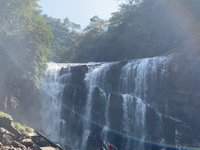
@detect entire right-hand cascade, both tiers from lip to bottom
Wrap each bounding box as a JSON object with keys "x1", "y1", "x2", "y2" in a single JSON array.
[{"x1": 119, "y1": 57, "x2": 168, "y2": 150}]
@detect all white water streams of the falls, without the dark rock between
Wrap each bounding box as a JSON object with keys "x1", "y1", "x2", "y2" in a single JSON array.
[{"x1": 40, "y1": 57, "x2": 170, "y2": 150}]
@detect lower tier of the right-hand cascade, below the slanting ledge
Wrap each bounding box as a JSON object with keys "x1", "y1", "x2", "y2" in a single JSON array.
[{"x1": 122, "y1": 94, "x2": 146, "y2": 150}]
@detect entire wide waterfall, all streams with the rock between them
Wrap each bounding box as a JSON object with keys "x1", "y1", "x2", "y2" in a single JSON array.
[{"x1": 38, "y1": 57, "x2": 186, "y2": 150}]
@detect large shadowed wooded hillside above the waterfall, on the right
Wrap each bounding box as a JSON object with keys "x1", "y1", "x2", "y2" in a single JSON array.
[{"x1": 53, "y1": 0, "x2": 200, "y2": 62}]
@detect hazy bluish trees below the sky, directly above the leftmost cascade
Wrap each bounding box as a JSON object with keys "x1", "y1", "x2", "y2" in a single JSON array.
[{"x1": 45, "y1": 16, "x2": 80, "y2": 62}]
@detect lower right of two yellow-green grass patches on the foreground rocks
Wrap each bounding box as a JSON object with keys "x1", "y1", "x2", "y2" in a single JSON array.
[{"x1": 12, "y1": 122, "x2": 34, "y2": 136}]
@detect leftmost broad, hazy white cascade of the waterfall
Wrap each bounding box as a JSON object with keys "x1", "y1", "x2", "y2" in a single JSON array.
[{"x1": 40, "y1": 63, "x2": 64, "y2": 142}]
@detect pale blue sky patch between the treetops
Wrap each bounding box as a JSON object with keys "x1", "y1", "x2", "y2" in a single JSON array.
[{"x1": 39, "y1": 0, "x2": 119, "y2": 27}]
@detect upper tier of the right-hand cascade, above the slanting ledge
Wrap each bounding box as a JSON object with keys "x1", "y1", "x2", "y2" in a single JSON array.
[{"x1": 119, "y1": 57, "x2": 169, "y2": 95}]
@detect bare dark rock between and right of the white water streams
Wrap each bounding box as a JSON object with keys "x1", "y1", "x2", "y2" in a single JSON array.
[{"x1": 59, "y1": 55, "x2": 200, "y2": 150}]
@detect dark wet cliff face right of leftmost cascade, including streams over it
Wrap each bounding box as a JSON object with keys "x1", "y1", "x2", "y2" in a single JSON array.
[{"x1": 39, "y1": 54, "x2": 200, "y2": 150}]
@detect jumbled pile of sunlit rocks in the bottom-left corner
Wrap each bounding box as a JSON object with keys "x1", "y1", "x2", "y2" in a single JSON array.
[{"x1": 0, "y1": 113, "x2": 63, "y2": 150}]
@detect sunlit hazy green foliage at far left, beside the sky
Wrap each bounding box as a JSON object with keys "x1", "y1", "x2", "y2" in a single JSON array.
[{"x1": 0, "y1": 0, "x2": 52, "y2": 88}]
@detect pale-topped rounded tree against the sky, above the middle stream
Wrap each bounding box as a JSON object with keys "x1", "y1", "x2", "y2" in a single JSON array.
[{"x1": 72, "y1": 16, "x2": 108, "y2": 62}]
